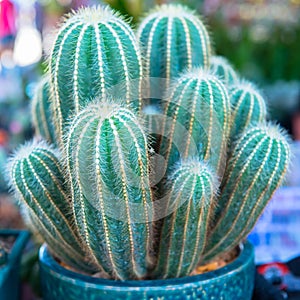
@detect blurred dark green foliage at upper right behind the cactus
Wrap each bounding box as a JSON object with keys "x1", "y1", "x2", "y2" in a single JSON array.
[{"x1": 208, "y1": 15, "x2": 300, "y2": 83}]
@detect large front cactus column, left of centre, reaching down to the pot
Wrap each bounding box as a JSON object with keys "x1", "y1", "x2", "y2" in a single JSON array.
[{"x1": 66, "y1": 103, "x2": 152, "y2": 280}]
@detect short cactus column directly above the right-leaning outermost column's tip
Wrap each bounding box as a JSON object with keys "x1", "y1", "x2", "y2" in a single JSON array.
[{"x1": 229, "y1": 81, "x2": 267, "y2": 140}]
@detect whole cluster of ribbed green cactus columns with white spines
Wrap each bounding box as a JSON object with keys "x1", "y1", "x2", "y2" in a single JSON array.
[{"x1": 8, "y1": 5, "x2": 290, "y2": 280}]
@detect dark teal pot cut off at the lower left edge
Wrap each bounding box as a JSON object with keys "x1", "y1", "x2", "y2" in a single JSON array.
[{"x1": 0, "y1": 230, "x2": 30, "y2": 300}]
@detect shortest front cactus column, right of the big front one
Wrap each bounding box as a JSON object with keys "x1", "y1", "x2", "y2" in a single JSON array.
[{"x1": 154, "y1": 161, "x2": 217, "y2": 278}]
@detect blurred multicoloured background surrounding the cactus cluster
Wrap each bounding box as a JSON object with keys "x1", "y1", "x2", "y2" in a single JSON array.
[{"x1": 0, "y1": 0, "x2": 300, "y2": 298}]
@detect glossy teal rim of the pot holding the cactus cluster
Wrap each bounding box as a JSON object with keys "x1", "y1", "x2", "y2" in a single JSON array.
[{"x1": 39, "y1": 241, "x2": 254, "y2": 289}]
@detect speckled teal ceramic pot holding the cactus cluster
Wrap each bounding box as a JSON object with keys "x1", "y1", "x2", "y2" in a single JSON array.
[{"x1": 40, "y1": 242, "x2": 255, "y2": 300}]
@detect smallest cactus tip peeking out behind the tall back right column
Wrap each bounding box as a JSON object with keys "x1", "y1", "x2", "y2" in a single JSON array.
[{"x1": 210, "y1": 56, "x2": 238, "y2": 85}]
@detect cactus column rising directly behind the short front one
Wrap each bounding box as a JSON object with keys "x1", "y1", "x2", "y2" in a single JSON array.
[{"x1": 159, "y1": 68, "x2": 230, "y2": 175}]
